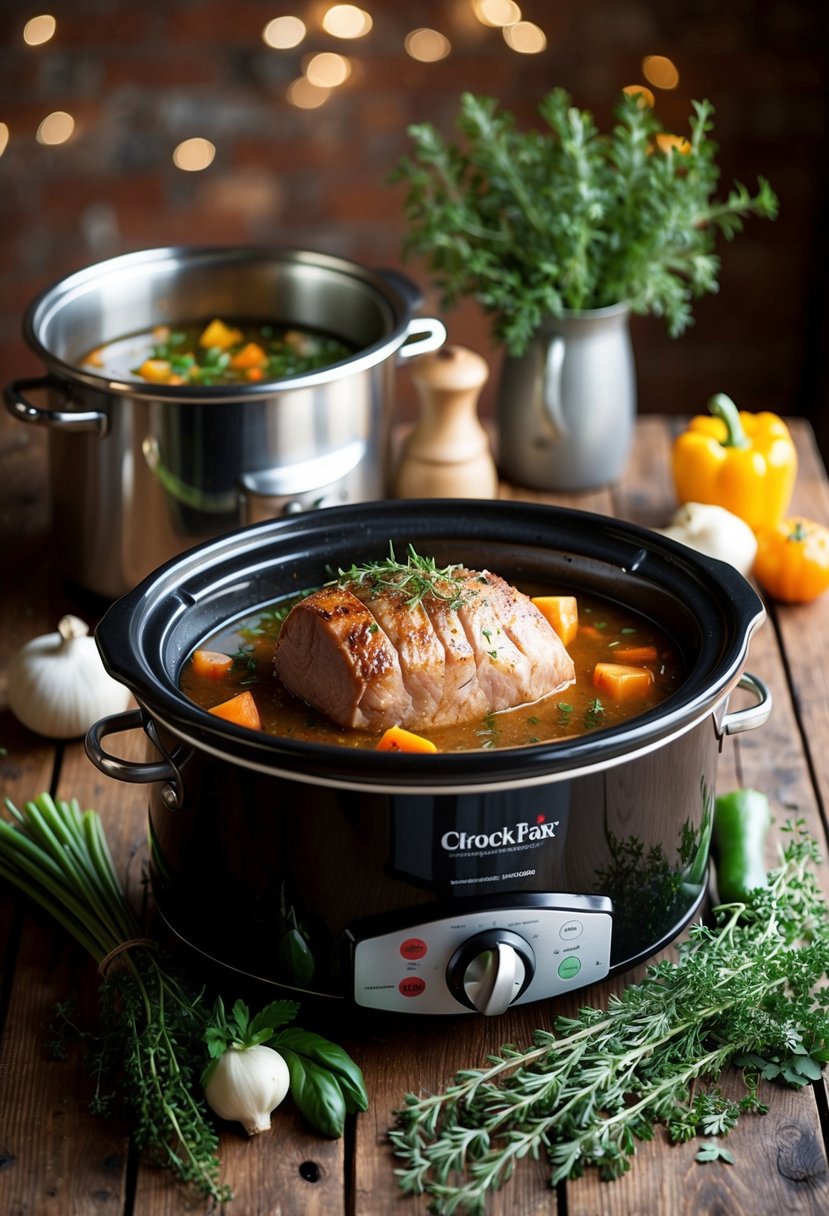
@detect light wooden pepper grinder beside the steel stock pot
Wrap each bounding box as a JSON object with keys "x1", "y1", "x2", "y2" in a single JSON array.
[{"x1": 394, "y1": 347, "x2": 498, "y2": 499}]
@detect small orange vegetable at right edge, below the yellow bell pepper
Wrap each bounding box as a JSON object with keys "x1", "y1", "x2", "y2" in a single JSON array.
[{"x1": 754, "y1": 516, "x2": 829, "y2": 604}]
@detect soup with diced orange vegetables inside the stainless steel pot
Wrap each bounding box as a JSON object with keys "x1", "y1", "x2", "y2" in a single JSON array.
[{"x1": 80, "y1": 317, "x2": 355, "y2": 384}]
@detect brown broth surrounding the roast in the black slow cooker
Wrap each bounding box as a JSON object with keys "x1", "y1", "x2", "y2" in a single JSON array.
[{"x1": 181, "y1": 587, "x2": 683, "y2": 751}]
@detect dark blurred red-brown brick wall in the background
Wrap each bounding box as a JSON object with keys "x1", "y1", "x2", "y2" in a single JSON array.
[{"x1": 0, "y1": 0, "x2": 829, "y2": 457}]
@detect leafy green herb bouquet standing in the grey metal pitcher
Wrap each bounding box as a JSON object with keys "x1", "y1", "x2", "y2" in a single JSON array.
[{"x1": 391, "y1": 89, "x2": 777, "y2": 355}]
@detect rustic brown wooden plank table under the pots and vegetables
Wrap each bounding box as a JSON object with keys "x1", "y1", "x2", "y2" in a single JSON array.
[{"x1": 0, "y1": 416, "x2": 829, "y2": 1216}]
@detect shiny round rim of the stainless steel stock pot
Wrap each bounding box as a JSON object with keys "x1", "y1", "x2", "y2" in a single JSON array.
[{"x1": 22, "y1": 244, "x2": 419, "y2": 404}]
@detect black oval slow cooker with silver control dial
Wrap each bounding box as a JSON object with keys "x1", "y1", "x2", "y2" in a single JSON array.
[{"x1": 86, "y1": 500, "x2": 771, "y2": 1014}]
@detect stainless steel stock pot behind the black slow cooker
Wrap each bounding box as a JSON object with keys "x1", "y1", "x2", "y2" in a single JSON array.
[{"x1": 5, "y1": 247, "x2": 446, "y2": 599}]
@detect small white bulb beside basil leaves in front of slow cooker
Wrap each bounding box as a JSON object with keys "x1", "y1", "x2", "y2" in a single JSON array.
[{"x1": 204, "y1": 1043, "x2": 291, "y2": 1136}]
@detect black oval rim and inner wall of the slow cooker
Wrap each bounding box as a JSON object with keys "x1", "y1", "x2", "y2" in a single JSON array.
[{"x1": 96, "y1": 500, "x2": 765, "y2": 792}]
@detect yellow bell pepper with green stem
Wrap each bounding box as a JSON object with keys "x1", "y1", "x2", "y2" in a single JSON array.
[{"x1": 672, "y1": 393, "x2": 797, "y2": 531}]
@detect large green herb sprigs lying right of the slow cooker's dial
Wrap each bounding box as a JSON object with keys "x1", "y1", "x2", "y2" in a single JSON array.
[{"x1": 389, "y1": 823, "x2": 829, "y2": 1216}]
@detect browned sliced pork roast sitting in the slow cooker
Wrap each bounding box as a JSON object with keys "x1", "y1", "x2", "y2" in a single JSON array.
[{"x1": 273, "y1": 568, "x2": 575, "y2": 731}]
